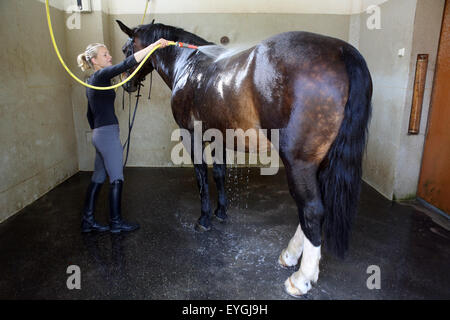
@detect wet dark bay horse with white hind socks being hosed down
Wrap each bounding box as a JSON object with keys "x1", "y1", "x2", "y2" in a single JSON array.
[{"x1": 117, "y1": 21, "x2": 372, "y2": 297}]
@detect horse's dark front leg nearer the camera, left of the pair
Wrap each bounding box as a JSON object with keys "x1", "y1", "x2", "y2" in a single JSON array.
[{"x1": 191, "y1": 135, "x2": 211, "y2": 232}]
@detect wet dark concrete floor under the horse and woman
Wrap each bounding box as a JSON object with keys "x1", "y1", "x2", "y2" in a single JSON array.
[{"x1": 0, "y1": 168, "x2": 450, "y2": 300}]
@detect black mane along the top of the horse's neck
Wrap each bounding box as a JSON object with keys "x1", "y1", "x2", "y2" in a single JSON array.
[{"x1": 135, "y1": 23, "x2": 214, "y2": 46}]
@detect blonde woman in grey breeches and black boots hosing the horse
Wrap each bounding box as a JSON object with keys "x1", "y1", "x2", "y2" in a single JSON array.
[{"x1": 77, "y1": 39, "x2": 168, "y2": 233}]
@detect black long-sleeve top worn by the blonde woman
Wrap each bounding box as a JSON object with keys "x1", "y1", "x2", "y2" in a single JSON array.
[{"x1": 86, "y1": 55, "x2": 138, "y2": 129}]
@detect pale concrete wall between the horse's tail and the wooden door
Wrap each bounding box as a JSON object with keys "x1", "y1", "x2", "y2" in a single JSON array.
[{"x1": 356, "y1": 0, "x2": 444, "y2": 199}]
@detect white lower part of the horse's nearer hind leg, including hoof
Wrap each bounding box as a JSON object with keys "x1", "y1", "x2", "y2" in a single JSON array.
[{"x1": 284, "y1": 237, "x2": 320, "y2": 296}]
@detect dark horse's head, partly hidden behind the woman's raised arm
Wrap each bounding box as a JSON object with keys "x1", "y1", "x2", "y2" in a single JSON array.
[{"x1": 116, "y1": 20, "x2": 154, "y2": 92}]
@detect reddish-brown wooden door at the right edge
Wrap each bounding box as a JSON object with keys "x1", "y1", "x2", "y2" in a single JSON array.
[{"x1": 417, "y1": 0, "x2": 450, "y2": 215}]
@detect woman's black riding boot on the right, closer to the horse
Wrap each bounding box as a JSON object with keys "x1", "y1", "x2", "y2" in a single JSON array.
[{"x1": 109, "y1": 180, "x2": 139, "y2": 233}]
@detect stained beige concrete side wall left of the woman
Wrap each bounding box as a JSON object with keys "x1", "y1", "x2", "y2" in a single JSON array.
[{"x1": 0, "y1": 0, "x2": 78, "y2": 221}]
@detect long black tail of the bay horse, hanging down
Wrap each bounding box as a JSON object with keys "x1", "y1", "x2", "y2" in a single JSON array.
[{"x1": 318, "y1": 45, "x2": 372, "y2": 257}]
